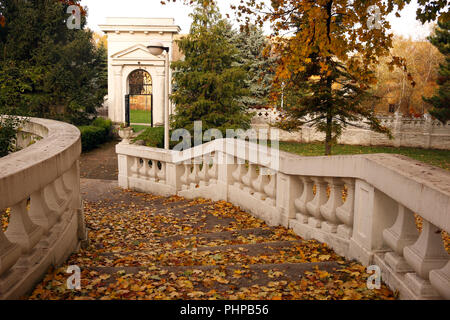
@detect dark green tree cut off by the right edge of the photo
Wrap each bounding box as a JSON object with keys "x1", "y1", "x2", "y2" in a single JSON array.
[{"x1": 424, "y1": 16, "x2": 450, "y2": 124}]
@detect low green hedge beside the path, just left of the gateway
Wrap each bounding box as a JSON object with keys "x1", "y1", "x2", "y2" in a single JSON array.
[{"x1": 78, "y1": 118, "x2": 112, "y2": 152}]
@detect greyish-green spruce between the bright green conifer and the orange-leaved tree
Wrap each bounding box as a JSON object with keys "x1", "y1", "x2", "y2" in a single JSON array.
[{"x1": 233, "y1": 25, "x2": 276, "y2": 108}]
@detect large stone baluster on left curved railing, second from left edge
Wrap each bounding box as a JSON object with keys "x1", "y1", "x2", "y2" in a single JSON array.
[{"x1": 5, "y1": 200, "x2": 43, "y2": 262}]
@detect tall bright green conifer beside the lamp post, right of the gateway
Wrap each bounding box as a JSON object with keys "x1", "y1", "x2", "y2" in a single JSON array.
[{"x1": 171, "y1": 0, "x2": 251, "y2": 138}]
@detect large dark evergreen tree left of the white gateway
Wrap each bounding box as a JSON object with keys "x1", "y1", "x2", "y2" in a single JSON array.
[{"x1": 0, "y1": 0, "x2": 107, "y2": 125}]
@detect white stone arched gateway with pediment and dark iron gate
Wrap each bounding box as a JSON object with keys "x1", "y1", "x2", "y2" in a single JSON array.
[{"x1": 100, "y1": 18, "x2": 180, "y2": 126}]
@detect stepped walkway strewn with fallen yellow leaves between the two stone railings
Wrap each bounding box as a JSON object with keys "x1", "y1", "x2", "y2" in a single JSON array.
[{"x1": 26, "y1": 143, "x2": 393, "y2": 300}]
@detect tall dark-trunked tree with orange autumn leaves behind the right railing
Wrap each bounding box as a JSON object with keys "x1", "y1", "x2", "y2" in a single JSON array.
[{"x1": 234, "y1": 0, "x2": 446, "y2": 155}]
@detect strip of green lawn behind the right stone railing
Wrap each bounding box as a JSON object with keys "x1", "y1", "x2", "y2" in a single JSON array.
[{"x1": 280, "y1": 142, "x2": 450, "y2": 170}]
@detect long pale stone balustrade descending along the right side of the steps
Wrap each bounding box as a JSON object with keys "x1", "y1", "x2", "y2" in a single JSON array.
[{"x1": 116, "y1": 139, "x2": 450, "y2": 299}]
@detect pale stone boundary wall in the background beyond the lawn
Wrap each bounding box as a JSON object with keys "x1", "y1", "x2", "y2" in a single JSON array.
[{"x1": 249, "y1": 109, "x2": 450, "y2": 150}]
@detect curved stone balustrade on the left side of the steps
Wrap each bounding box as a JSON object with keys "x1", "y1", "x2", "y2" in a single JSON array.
[{"x1": 0, "y1": 118, "x2": 87, "y2": 299}]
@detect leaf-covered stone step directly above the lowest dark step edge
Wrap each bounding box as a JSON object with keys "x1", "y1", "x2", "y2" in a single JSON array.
[{"x1": 71, "y1": 240, "x2": 340, "y2": 267}]
